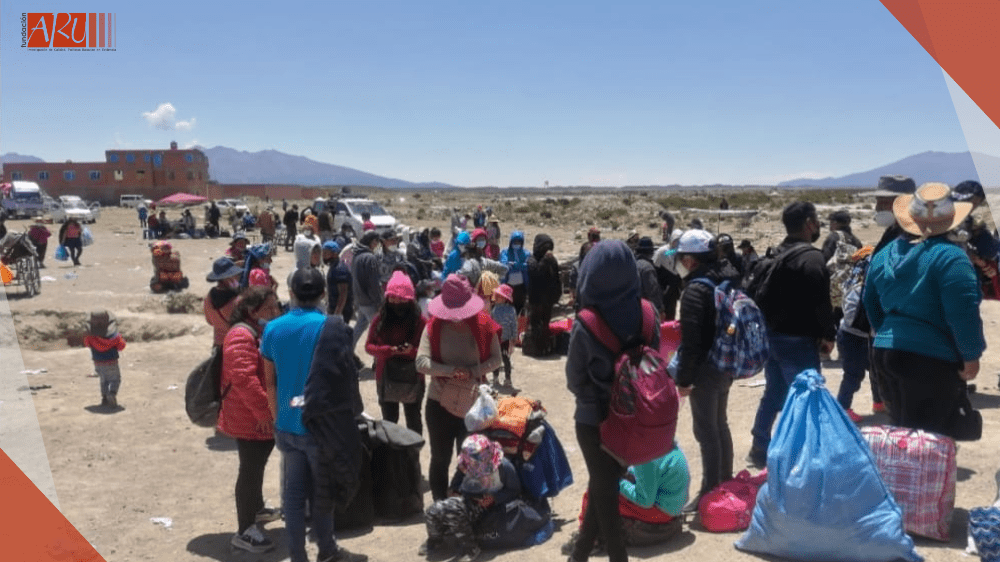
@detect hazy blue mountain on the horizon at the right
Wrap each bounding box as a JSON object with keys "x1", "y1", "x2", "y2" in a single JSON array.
[{"x1": 778, "y1": 152, "x2": 1000, "y2": 189}]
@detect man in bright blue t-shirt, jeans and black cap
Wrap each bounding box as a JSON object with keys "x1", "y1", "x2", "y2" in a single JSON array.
[{"x1": 260, "y1": 268, "x2": 368, "y2": 562}]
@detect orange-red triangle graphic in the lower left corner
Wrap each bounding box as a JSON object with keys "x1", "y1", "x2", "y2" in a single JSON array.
[{"x1": 0, "y1": 450, "x2": 105, "y2": 562}]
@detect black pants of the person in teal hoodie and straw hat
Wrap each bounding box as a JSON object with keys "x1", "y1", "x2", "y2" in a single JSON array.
[{"x1": 872, "y1": 347, "x2": 965, "y2": 435}]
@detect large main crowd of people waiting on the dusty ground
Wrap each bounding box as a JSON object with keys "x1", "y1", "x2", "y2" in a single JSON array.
[{"x1": 178, "y1": 177, "x2": 996, "y2": 562}]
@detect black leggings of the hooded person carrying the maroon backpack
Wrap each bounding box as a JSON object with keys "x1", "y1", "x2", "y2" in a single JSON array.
[{"x1": 573, "y1": 423, "x2": 628, "y2": 562}]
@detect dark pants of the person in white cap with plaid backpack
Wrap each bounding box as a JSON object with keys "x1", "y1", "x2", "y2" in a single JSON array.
[{"x1": 689, "y1": 365, "x2": 733, "y2": 494}]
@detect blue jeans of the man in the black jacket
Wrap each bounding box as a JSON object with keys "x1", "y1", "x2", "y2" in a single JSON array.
[{"x1": 750, "y1": 330, "x2": 820, "y2": 451}]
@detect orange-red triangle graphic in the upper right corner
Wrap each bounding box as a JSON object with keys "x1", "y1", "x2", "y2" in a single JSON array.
[{"x1": 881, "y1": 0, "x2": 1000, "y2": 126}]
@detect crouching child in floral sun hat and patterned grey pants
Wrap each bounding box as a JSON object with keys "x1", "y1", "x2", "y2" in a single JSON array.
[{"x1": 418, "y1": 433, "x2": 521, "y2": 562}]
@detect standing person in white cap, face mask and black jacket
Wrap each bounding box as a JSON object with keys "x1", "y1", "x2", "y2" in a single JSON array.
[{"x1": 677, "y1": 230, "x2": 740, "y2": 513}]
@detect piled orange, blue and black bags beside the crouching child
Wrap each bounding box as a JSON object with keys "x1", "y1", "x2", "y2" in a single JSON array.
[{"x1": 460, "y1": 396, "x2": 573, "y2": 549}]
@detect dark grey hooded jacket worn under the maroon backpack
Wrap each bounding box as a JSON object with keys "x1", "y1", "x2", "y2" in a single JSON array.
[{"x1": 566, "y1": 240, "x2": 660, "y2": 426}]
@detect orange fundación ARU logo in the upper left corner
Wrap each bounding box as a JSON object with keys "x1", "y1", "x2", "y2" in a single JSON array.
[{"x1": 21, "y1": 12, "x2": 118, "y2": 51}]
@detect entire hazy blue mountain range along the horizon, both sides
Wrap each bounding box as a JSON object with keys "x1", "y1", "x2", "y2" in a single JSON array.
[{"x1": 0, "y1": 146, "x2": 1000, "y2": 189}]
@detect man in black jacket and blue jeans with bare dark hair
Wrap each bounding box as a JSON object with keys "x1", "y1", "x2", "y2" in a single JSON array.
[{"x1": 747, "y1": 201, "x2": 836, "y2": 468}]
